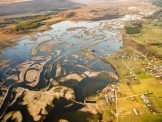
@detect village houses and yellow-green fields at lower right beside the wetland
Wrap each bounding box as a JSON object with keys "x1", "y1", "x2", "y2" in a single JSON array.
[{"x1": 106, "y1": 48, "x2": 162, "y2": 122}]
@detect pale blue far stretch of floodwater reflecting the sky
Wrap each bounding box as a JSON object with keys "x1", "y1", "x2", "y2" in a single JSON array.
[{"x1": 2, "y1": 21, "x2": 122, "y2": 65}]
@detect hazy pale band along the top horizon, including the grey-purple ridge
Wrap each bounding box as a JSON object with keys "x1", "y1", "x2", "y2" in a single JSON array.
[{"x1": 0, "y1": 0, "x2": 130, "y2": 16}]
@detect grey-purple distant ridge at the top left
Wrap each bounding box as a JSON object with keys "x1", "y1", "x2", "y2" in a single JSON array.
[{"x1": 0, "y1": 0, "x2": 82, "y2": 16}]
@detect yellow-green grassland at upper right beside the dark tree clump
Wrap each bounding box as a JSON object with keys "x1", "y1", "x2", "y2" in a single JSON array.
[{"x1": 125, "y1": 20, "x2": 162, "y2": 58}]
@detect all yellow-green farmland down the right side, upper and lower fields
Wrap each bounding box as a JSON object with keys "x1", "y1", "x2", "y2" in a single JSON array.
[{"x1": 108, "y1": 22, "x2": 162, "y2": 122}]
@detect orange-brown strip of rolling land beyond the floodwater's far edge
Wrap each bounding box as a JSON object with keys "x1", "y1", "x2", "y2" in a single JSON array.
[{"x1": 0, "y1": 0, "x2": 159, "y2": 50}]
